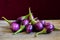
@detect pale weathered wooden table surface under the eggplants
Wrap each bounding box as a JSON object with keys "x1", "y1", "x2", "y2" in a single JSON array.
[{"x1": 0, "y1": 20, "x2": 60, "y2": 40}]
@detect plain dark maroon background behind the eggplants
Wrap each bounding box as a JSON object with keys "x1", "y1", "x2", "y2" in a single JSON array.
[{"x1": 0, "y1": 0, "x2": 60, "y2": 19}]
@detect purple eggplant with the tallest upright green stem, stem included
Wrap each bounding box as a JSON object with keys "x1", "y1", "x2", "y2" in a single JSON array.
[{"x1": 29, "y1": 8, "x2": 44, "y2": 31}]
